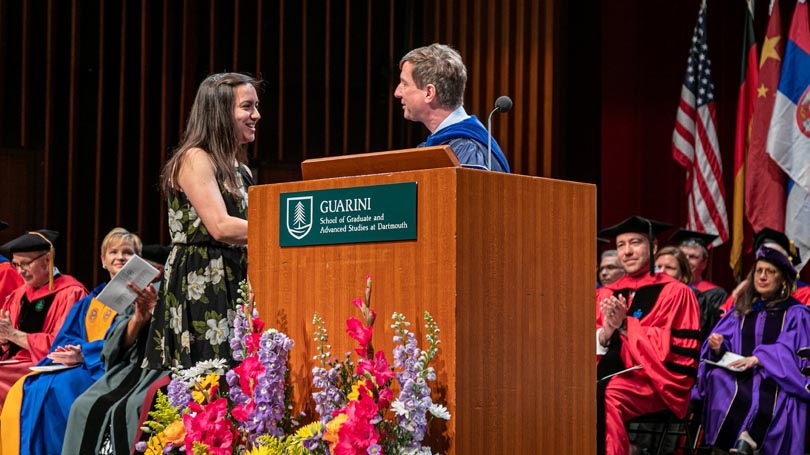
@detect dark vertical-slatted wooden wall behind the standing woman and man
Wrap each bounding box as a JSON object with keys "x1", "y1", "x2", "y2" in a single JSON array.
[{"x1": 0, "y1": 0, "x2": 560, "y2": 292}]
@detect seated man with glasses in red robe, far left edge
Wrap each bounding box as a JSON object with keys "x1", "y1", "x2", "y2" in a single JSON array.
[{"x1": 0, "y1": 229, "x2": 87, "y2": 410}]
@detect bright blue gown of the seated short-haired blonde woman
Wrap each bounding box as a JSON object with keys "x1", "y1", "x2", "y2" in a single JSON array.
[{"x1": 20, "y1": 283, "x2": 115, "y2": 455}]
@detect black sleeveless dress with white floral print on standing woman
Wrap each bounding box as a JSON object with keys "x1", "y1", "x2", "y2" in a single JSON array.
[{"x1": 143, "y1": 166, "x2": 253, "y2": 370}]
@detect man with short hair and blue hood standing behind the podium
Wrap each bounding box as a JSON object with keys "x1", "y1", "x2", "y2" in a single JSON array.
[{"x1": 394, "y1": 43, "x2": 509, "y2": 172}]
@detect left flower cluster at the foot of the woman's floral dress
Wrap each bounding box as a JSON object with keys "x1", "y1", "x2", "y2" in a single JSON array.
[{"x1": 136, "y1": 283, "x2": 297, "y2": 455}]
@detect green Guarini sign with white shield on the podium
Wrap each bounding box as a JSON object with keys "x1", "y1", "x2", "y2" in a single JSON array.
[{"x1": 278, "y1": 182, "x2": 416, "y2": 247}]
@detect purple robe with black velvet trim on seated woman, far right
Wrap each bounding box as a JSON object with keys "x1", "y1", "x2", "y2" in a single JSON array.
[{"x1": 693, "y1": 297, "x2": 810, "y2": 455}]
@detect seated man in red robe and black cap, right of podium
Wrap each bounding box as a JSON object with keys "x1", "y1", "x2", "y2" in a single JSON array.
[{"x1": 596, "y1": 217, "x2": 700, "y2": 455}]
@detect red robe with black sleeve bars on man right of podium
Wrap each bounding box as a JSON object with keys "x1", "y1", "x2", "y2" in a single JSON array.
[{"x1": 596, "y1": 273, "x2": 700, "y2": 455}]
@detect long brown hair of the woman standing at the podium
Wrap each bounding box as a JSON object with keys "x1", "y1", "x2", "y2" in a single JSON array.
[{"x1": 160, "y1": 73, "x2": 261, "y2": 196}]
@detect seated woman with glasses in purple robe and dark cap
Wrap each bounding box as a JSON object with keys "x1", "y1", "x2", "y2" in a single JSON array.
[{"x1": 693, "y1": 246, "x2": 810, "y2": 455}]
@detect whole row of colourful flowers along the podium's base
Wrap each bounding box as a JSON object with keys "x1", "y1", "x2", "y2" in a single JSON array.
[{"x1": 138, "y1": 277, "x2": 450, "y2": 455}]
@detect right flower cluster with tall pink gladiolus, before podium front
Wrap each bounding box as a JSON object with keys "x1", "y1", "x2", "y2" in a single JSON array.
[{"x1": 309, "y1": 276, "x2": 450, "y2": 455}]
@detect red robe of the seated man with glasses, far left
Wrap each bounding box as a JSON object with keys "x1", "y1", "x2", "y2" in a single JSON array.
[{"x1": 0, "y1": 275, "x2": 87, "y2": 409}]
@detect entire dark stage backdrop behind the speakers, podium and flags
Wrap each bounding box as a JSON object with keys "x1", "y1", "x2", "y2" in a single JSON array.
[{"x1": 0, "y1": 0, "x2": 795, "y2": 292}]
